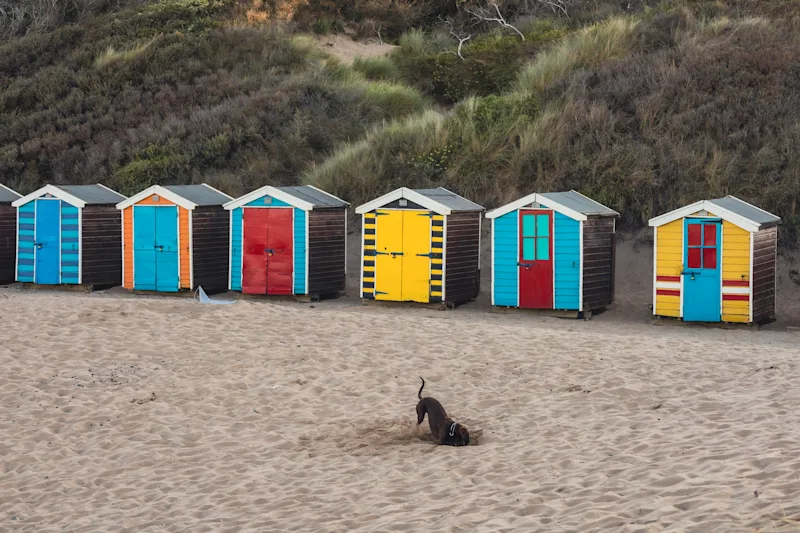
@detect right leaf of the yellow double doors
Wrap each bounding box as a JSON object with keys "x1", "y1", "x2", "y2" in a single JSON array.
[{"x1": 402, "y1": 211, "x2": 431, "y2": 303}]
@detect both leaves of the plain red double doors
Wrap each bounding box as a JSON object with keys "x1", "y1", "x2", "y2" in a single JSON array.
[{"x1": 242, "y1": 208, "x2": 293, "y2": 294}]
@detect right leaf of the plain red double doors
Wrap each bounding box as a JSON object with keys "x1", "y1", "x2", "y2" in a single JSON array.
[{"x1": 263, "y1": 209, "x2": 294, "y2": 294}]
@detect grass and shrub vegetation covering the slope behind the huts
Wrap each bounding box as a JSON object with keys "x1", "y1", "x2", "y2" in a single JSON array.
[{"x1": 0, "y1": 0, "x2": 800, "y2": 245}]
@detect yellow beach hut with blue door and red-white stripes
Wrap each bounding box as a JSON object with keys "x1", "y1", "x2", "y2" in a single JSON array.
[{"x1": 650, "y1": 196, "x2": 780, "y2": 323}]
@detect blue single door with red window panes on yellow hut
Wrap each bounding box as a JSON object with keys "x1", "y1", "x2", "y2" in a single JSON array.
[{"x1": 682, "y1": 218, "x2": 722, "y2": 322}]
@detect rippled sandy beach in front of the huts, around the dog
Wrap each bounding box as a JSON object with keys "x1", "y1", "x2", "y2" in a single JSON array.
[{"x1": 0, "y1": 238, "x2": 800, "y2": 533}]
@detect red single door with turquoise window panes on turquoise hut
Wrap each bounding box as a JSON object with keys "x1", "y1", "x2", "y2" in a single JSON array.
[{"x1": 517, "y1": 209, "x2": 553, "y2": 309}]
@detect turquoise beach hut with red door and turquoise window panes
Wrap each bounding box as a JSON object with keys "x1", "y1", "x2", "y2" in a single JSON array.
[{"x1": 486, "y1": 191, "x2": 619, "y2": 316}]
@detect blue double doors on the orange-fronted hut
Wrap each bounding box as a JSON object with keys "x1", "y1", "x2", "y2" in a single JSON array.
[{"x1": 133, "y1": 206, "x2": 179, "y2": 292}]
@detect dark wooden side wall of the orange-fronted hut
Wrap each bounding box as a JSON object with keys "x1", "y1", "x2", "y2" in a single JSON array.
[{"x1": 191, "y1": 206, "x2": 231, "y2": 293}]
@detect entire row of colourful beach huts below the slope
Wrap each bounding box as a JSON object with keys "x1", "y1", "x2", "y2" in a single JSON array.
[{"x1": 0, "y1": 184, "x2": 780, "y2": 323}]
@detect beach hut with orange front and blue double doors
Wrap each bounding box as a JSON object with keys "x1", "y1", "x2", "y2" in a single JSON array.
[{"x1": 117, "y1": 184, "x2": 233, "y2": 292}]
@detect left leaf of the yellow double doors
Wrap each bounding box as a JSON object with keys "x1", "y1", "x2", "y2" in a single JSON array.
[{"x1": 375, "y1": 209, "x2": 403, "y2": 301}]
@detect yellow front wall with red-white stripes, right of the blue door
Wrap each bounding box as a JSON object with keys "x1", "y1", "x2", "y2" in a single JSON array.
[{"x1": 721, "y1": 220, "x2": 751, "y2": 323}]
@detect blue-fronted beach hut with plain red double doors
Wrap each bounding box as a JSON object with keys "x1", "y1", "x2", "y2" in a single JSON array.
[{"x1": 225, "y1": 185, "x2": 349, "y2": 298}]
